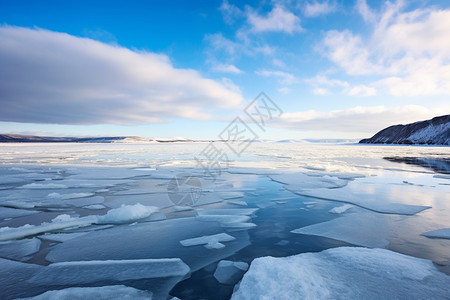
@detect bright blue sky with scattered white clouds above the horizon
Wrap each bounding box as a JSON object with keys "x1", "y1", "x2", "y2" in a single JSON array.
[{"x1": 0, "y1": 0, "x2": 450, "y2": 139}]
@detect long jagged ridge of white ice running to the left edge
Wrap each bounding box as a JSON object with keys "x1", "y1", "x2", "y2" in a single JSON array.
[{"x1": 0, "y1": 203, "x2": 158, "y2": 241}]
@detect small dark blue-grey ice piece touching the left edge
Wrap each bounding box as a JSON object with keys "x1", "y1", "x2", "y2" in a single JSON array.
[{"x1": 0, "y1": 238, "x2": 41, "y2": 260}]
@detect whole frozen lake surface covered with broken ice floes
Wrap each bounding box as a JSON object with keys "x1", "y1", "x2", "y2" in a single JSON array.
[{"x1": 0, "y1": 143, "x2": 450, "y2": 299}]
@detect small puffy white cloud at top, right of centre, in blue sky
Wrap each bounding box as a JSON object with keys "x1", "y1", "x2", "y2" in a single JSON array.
[{"x1": 247, "y1": 5, "x2": 302, "y2": 33}]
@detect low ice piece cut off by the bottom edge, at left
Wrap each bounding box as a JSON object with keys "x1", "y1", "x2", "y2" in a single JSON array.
[{"x1": 22, "y1": 285, "x2": 152, "y2": 300}]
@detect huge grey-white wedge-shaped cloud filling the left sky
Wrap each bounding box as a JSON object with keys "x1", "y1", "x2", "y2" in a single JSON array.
[{"x1": 0, "y1": 26, "x2": 242, "y2": 124}]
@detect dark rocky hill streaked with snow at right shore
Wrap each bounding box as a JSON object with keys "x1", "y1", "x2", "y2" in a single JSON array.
[{"x1": 359, "y1": 115, "x2": 450, "y2": 145}]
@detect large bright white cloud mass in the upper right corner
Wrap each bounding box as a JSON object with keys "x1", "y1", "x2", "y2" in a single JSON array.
[{"x1": 323, "y1": 1, "x2": 450, "y2": 96}]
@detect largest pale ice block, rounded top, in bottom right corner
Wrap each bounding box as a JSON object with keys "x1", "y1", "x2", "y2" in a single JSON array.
[{"x1": 232, "y1": 247, "x2": 450, "y2": 300}]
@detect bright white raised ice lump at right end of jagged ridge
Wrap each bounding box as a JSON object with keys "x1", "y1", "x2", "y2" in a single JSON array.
[{"x1": 96, "y1": 203, "x2": 158, "y2": 224}]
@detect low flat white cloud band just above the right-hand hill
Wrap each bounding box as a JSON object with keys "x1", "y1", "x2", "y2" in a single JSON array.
[{"x1": 276, "y1": 105, "x2": 442, "y2": 135}]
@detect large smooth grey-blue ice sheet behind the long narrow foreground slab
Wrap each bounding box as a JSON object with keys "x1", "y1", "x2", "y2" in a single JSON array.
[{"x1": 46, "y1": 217, "x2": 249, "y2": 271}]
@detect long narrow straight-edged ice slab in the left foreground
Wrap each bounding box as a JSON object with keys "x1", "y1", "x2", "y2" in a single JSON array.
[{"x1": 28, "y1": 258, "x2": 190, "y2": 285}]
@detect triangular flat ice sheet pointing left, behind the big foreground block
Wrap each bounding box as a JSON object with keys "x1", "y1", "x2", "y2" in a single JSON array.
[{"x1": 291, "y1": 213, "x2": 391, "y2": 248}]
